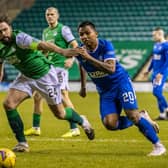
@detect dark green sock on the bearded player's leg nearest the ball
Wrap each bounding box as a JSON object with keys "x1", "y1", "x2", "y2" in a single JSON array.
[{"x1": 6, "y1": 109, "x2": 26, "y2": 142}]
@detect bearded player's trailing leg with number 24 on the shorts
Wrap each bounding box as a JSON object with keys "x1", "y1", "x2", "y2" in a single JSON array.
[{"x1": 36, "y1": 66, "x2": 94, "y2": 140}]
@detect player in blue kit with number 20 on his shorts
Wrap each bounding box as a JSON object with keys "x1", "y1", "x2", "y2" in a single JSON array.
[{"x1": 75, "y1": 21, "x2": 166, "y2": 156}]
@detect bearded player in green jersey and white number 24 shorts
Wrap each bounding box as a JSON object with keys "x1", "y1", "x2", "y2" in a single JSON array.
[{"x1": 0, "y1": 15, "x2": 94, "y2": 152}]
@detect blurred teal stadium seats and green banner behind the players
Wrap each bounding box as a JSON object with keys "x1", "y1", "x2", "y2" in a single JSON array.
[{"x1": 0, "y1": 0, "x2": 168, "y2": 91}]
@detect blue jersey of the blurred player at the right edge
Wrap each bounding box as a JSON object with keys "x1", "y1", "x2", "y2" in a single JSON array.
[{"x1": 148, "y1": 42, "x2": 168, "y2": 78}]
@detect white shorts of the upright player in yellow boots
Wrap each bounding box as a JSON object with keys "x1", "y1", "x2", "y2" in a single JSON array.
[{"x1": 56, "y1": 67, "x2": 69, "y2": 90}]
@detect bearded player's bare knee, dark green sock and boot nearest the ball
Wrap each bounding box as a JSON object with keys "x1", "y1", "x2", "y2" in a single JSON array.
[{"x1": 3, "y1": 88, "x2": 29, "y2": 152}]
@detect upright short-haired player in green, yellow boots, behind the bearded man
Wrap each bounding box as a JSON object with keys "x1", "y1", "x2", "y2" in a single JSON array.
[{"x1": 24, "y1": 7, "x2": 80, "y2": 138}]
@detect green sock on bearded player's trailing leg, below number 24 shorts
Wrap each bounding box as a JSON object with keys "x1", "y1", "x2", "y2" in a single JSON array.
[{"x1": 64, "y1": 108, "x2": 83, "y2": 125}]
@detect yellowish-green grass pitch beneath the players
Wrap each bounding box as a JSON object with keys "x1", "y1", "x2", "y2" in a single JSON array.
[{"x1": 0, "y1": 93, "x2": 168, "y2": 168}]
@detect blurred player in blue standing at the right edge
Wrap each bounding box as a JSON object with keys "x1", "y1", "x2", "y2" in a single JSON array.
[{"x1": 144, "y1": 27, "x2": 168, "y2": 120}]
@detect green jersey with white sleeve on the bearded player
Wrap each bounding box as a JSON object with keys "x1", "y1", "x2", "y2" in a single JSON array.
[{"x1": 0, "y1": 31, "x2": 52, "y2": 79}]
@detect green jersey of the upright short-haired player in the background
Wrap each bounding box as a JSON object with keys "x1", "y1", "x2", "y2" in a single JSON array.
[{"x1": 43, "y1": 23, "x2": 75, "y2": 67}]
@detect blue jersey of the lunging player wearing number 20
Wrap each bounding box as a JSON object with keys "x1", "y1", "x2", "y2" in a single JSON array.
[{"x1": 77, "y1": 39, "x2": 128, "y2": 93}]
